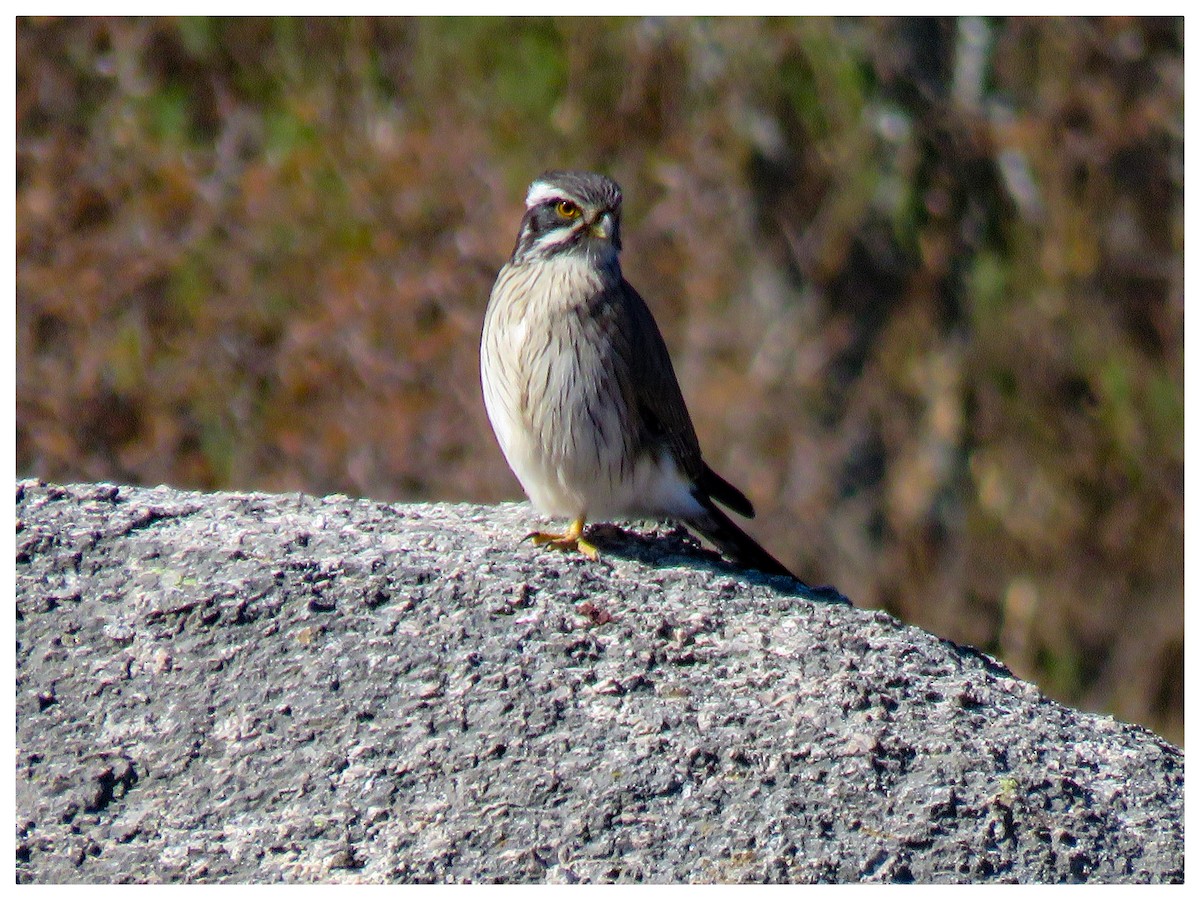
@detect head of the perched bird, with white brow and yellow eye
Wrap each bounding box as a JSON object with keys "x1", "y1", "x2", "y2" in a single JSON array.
[{"x1": 512, "y1": 172, "x2": 620, "y2": 265}]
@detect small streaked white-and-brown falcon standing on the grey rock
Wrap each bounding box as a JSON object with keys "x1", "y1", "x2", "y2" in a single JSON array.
[{"x1": 480, "y1": 169, "x2": 796, "y2": 578}]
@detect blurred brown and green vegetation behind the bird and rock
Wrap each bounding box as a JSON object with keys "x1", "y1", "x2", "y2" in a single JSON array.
[{"x1": 16, "y1": 18, "x2": 1183, "y2": 743}]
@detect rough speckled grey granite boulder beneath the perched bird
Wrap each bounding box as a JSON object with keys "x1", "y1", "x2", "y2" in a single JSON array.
[{"x1": 16, "y1": 481, "x2": 1183, "y2": 882}]
